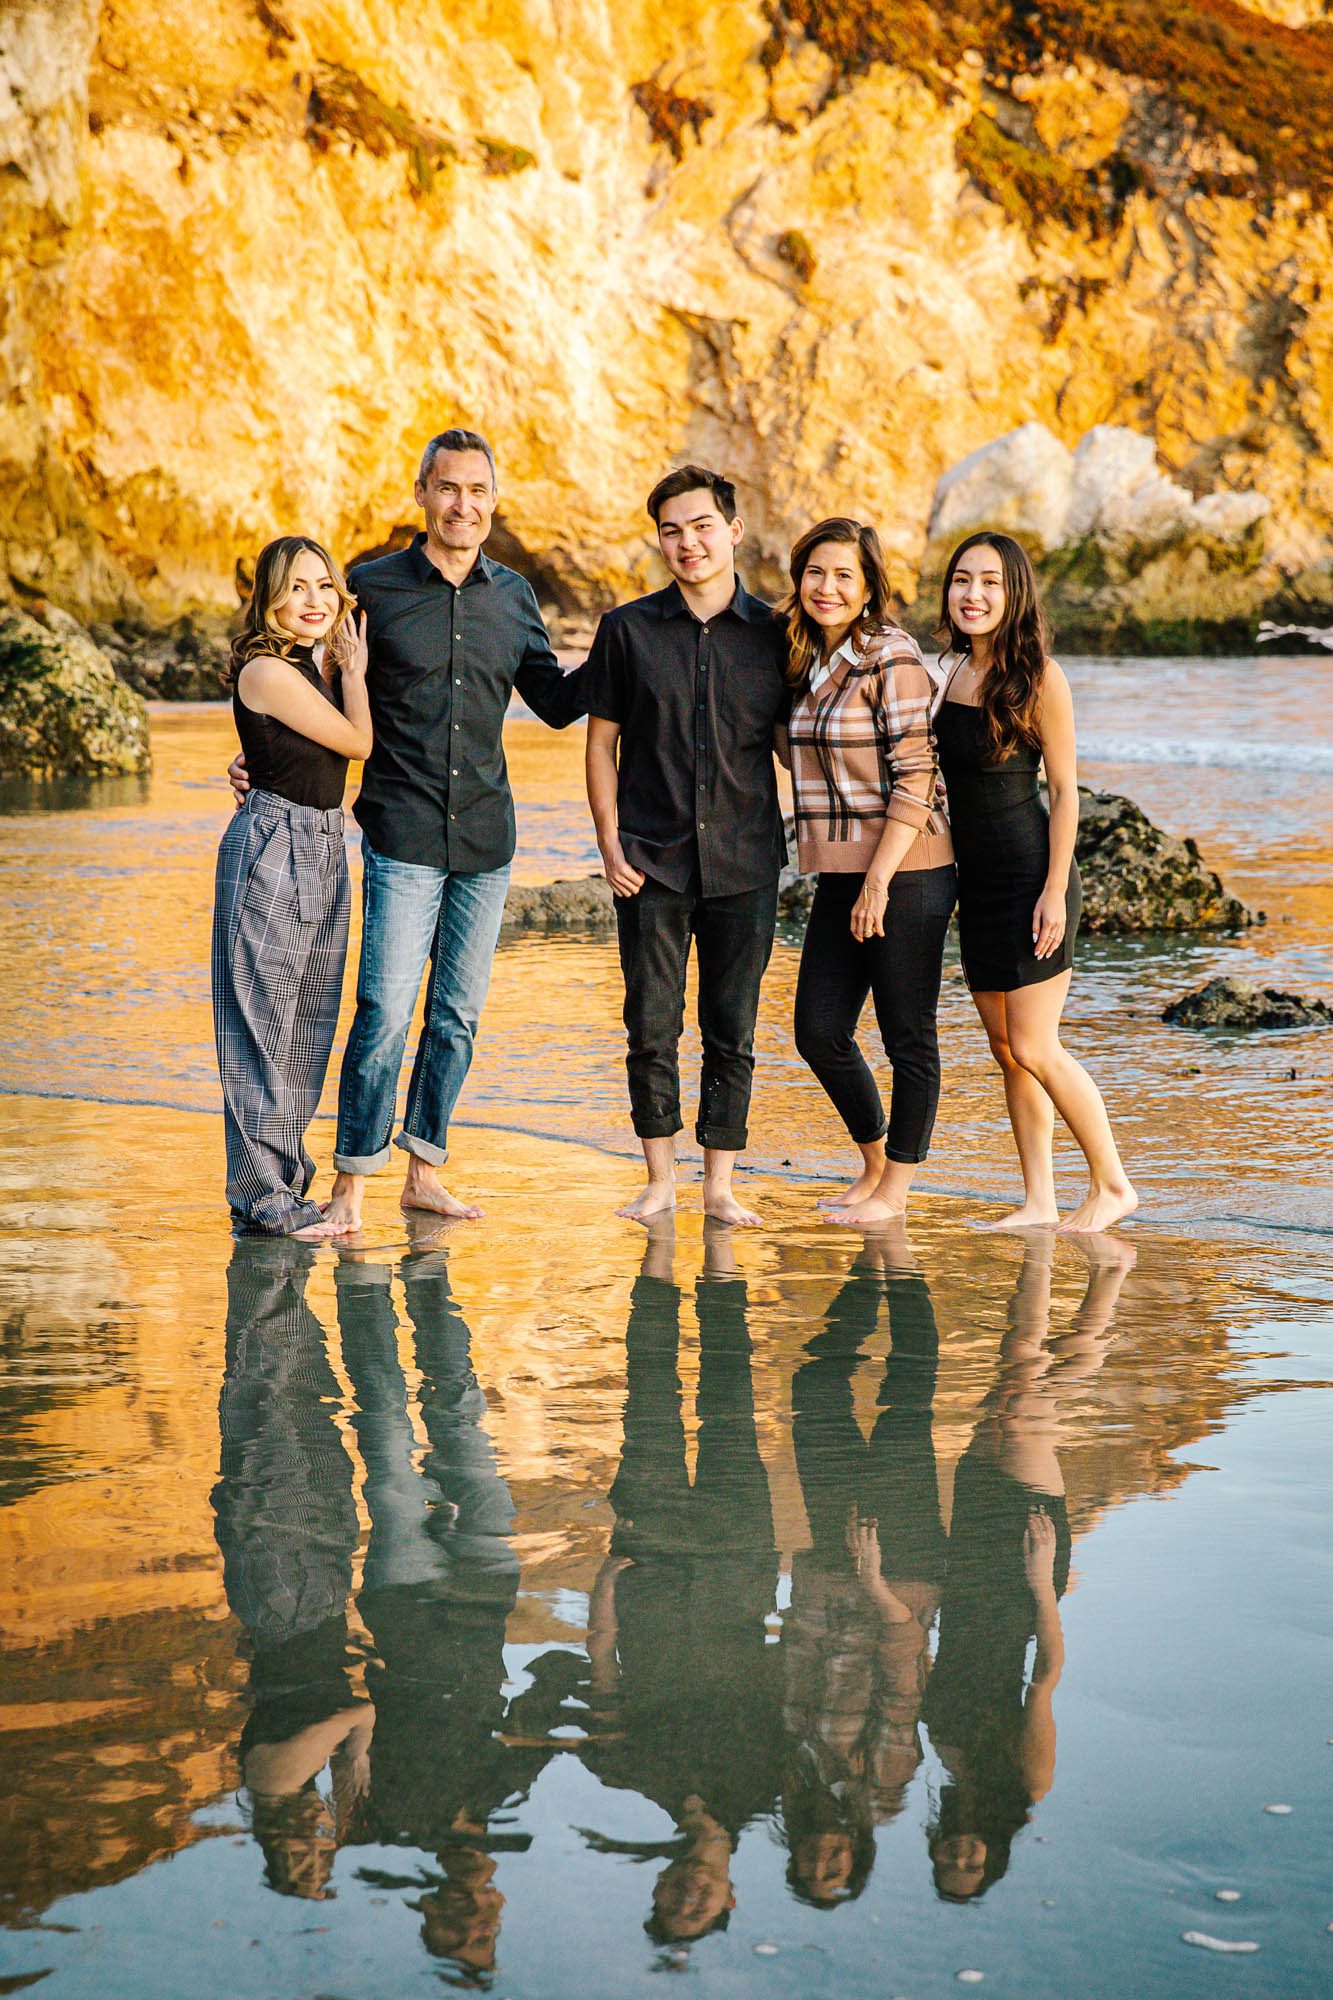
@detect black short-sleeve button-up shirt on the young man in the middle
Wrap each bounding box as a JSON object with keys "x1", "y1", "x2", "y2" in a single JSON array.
[{"x1": 584, "y1": 584, "x2": 791, "y2": 896}]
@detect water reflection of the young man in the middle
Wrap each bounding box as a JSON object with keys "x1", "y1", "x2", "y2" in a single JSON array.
[{"x1": 584, "y1": 1220, "x2": 779, "y2": 1942}]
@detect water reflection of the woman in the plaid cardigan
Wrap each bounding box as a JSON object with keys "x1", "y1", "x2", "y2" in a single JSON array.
[{"x1": 783, "y1": 1230, "x2": 945, "y2": 1908}]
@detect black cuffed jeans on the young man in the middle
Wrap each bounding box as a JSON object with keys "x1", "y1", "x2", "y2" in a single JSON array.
[{"x1": 616, "y1": 876, "x2": 777, "y2": 1152}]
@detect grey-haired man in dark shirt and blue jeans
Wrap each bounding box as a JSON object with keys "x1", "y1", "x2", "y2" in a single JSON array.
[{"x1": 232, "y1": 430, "x2": 584, "y2": 1230}]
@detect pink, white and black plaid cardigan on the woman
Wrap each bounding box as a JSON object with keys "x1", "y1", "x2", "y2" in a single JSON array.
[{"x1": 787, "y1": 626, "x2": 953, "y2": 874}]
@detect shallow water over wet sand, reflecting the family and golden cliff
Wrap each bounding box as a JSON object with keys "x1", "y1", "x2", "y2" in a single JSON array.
[{"x1": 0, "y1": 662, "x2": 1333, "y2": 2000}]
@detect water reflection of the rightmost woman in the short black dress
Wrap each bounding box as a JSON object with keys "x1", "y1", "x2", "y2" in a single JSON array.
[{"x1": 925, "y1": 1236, "x2": 1135, "y2": 1902}]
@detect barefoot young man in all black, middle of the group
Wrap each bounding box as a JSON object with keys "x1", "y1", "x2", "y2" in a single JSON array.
[{"x1": 584, "y1": 466, "x2": 789, "y2": 1222}]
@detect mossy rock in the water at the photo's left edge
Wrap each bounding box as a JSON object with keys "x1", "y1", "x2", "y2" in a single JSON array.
[{"x1": 0, "y1": 606, "x2": 152, "y2": 778}]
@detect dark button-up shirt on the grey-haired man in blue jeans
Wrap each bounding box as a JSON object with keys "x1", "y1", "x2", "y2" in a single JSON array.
[{"x1": 348, "y1": 534, "x2": 584, "y2": 874}]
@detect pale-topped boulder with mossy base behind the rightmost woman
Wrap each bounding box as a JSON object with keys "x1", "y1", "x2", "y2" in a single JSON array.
[{"x1": 923, "y1": 424, "x2": 1289, "y2": 652}]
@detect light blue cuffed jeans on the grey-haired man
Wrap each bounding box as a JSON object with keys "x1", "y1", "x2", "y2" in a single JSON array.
[{"x1": 334, "y1": 840, "x2": 508, "y2": 1174}]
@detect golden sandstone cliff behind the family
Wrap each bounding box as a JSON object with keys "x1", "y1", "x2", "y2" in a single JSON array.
[{"x1": 0, "y1": 0, "x2": 1333, "y2": 642}]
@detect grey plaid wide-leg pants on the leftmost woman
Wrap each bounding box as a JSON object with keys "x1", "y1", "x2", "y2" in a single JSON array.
[{"x1": 212, "y1": 792, "x2": 350, "y2": 1236}]
